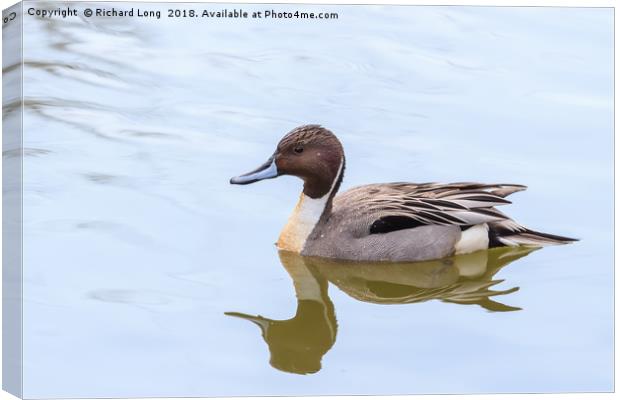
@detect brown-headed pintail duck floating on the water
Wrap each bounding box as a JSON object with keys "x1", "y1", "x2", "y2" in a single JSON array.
[{"x1": 230, "y1": 124, "x2": 578, "y2": 262}]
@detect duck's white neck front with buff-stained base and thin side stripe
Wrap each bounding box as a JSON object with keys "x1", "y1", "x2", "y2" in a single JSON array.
[{"x1": 276, "y1": 162, "x2": 344, "y2": 253}]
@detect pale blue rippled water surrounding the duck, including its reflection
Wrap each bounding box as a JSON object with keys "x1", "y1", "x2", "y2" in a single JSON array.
[{"x1": 5, "y1": 3, "x2": 613, "y2": 397}]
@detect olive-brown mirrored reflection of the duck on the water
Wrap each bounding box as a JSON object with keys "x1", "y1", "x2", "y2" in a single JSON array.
[{"x1": 226, "y1": 247, "x2": 537, "y2": 374}]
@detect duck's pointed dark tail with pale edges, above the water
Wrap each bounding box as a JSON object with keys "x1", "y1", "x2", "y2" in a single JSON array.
[{"x1": 489, "y1": 220, "x2": 579, "y2": 247}]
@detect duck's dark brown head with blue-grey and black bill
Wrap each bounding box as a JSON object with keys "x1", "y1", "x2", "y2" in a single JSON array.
[{"x1": 230, "y1": 125, "x2": 344, "y2": 199}]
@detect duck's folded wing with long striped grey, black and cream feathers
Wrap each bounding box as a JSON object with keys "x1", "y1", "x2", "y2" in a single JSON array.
[{"x1": 334, "y1": 182, "x2": 526, "y2": 234}]
